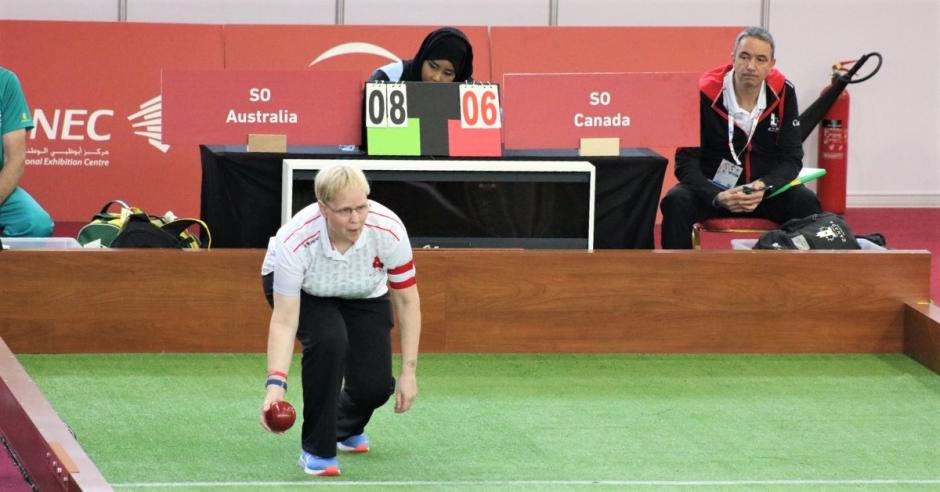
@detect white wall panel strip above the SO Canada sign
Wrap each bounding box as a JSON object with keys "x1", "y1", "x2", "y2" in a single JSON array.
[{"x1": 558, "y1": 0, "x2": 761, "y2": 26}]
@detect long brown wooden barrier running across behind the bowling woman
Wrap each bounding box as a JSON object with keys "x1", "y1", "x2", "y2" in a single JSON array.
[{"x1": 0, "y1": 249, "x2": 930, "y2": 353}]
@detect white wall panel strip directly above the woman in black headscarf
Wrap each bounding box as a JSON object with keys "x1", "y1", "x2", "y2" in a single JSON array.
[{"x1": 345, "y1": 0, "x2": 549, "y2": 26}]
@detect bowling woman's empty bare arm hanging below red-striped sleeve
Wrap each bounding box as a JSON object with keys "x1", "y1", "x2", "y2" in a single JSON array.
[{"x1": 391, "y1": 285, "x2": 421, "y2": 413}]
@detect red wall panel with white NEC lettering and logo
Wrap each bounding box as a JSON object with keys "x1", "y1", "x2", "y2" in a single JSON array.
[{"x1": 0, "y1": 21, "x2": 223, "y2": 221}]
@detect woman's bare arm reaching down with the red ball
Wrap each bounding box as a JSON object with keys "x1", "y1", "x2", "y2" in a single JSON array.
[{"x1": 260, "y1": 292, "x2": 300, "y2": 431}]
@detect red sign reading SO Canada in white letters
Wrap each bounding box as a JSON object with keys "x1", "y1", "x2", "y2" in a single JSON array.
[{"x1": 503, "y1": 72, "x2": 699, "y2": 149}]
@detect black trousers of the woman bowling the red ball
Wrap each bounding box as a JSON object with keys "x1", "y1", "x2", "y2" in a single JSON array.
[{"x1": 262, "y1": 274, "x2": 395, "y2": 458}]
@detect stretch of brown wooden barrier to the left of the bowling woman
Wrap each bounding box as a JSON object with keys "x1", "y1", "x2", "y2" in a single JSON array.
[{"x1": 0, "y1": 249, "x2": 270, "y2": 353}]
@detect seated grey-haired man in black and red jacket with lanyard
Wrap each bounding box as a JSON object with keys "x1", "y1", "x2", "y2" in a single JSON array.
[{"x1": 661, "y1": 27, "x2": 820, "y2": 249}]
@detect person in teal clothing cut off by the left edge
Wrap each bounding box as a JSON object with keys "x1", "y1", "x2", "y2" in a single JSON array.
[{"x1": 0, "y1": 67, "x2": 53, "y2": 237}]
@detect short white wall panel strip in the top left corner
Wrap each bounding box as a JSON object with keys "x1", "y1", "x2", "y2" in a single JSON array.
[{"x1": 0, "y1": 0, "x2": 118, "y2": 21}]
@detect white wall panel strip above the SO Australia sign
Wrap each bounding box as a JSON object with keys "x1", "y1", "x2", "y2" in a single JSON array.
[{"x1": 126, "y1": 0, "x2": 336, "y2": 24}]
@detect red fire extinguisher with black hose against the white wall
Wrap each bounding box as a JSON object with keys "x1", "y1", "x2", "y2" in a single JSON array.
[{"x1": 816, "y1": 53, "x2": 881, "y2": 214}]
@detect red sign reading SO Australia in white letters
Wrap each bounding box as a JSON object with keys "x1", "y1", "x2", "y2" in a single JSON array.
[{"x1": 162, "y1": 70, "x2": 362, "y2": 145}]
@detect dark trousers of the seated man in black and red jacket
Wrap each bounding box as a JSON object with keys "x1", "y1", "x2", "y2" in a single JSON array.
[{"x1": 660, "y1": 183, "x2": 821, "y2": 249}]
